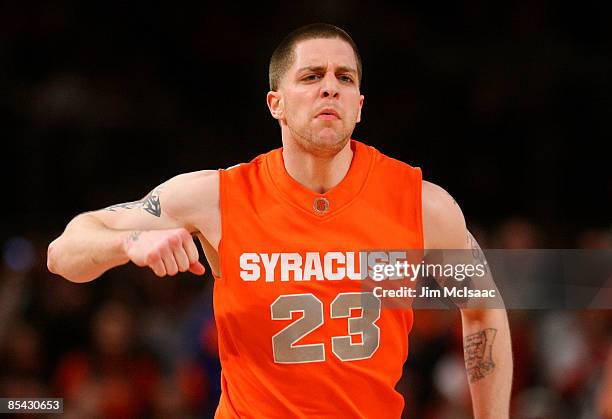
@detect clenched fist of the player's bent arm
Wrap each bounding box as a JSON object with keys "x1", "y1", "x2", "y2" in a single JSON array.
[{"x1": 123, "y1": 228, "x2": 206, "y2": 277}]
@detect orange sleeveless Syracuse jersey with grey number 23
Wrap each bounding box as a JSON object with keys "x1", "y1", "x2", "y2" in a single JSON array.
[{"x1": 214, "y1": 141, "x2": 423, "y2": 418}]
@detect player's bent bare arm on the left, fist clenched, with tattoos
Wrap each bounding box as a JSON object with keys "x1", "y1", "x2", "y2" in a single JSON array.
[{"x1": 47, "y1": 170, "x2": 219, "y2": 282}]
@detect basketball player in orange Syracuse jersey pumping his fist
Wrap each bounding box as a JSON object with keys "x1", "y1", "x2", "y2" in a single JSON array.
[{"x1": 48, "y1": 24, "x2": 512, "y2": 418}]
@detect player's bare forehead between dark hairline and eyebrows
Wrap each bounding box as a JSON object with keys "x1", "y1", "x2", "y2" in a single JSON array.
[{"x1": 291, "y1": 38, "x2": 357, "y2": 71}]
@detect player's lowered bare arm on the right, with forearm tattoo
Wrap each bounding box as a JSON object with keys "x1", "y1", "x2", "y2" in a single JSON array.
[{"x1": 423, "y1": 182, "x2": 512, "y2": 418}]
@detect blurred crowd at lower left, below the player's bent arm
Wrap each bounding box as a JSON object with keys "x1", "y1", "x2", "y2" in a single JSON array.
[{"x1": 0, "y1": 238, "x2": 220, "y2": 418}]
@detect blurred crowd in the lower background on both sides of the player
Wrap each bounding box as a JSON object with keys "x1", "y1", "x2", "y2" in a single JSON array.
[{"x1": 0, "y1": 219, "x2": 612, "y2": 419}]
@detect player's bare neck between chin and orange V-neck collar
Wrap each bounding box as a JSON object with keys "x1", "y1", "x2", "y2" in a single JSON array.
[{"x1": 283, "y1": 141, "x2": 353, "y2": 194}]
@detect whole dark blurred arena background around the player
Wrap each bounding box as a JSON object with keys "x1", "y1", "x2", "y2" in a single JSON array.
[{"x1": 0, "y1": 0, "x2": 612, "y2": 419}]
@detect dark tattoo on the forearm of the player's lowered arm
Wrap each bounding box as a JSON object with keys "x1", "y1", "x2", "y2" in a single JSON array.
[{"x1": 463, "y1": 328, "x2": 497, "y2": 383}]
